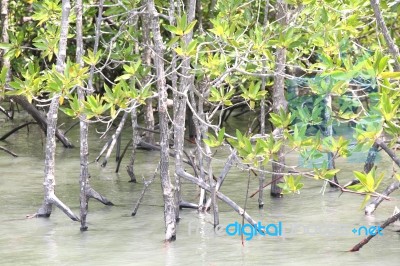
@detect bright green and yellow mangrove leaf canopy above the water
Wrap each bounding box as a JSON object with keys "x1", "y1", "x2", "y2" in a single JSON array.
[{"x1": 0, "y1": 0, "x2": 400, "y2": 208}]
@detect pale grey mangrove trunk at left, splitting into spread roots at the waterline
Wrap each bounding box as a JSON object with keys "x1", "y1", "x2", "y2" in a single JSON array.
[{"x1": 36, "y1": 0, "x2": 79, "y2": 221}]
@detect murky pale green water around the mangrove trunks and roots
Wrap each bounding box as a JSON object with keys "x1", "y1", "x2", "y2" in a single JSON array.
[{"x1": 0, "y1": 113, "x2": 400, "y2": 265}]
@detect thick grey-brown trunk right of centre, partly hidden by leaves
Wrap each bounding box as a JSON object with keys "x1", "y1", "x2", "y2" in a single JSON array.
[{"x1": 271, "y1": 0, "x2": 288, "y2": 197}]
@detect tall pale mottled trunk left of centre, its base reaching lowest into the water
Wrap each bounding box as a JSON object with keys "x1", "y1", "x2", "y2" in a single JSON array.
[{"x1": 147, "y1": 0, "x2": 176, "y2": 241}]
